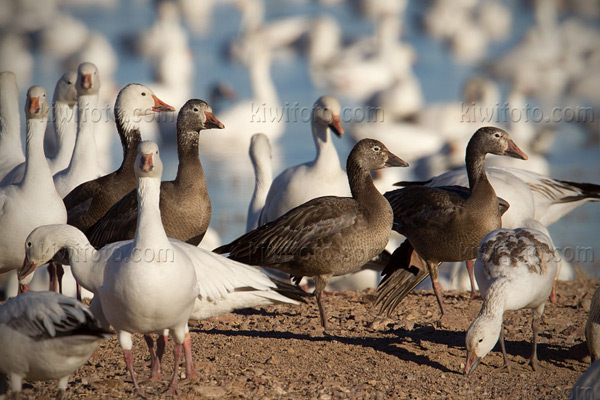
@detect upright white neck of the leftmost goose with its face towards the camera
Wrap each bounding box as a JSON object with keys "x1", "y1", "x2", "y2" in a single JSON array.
[{"x1": 21, "y1": 118, "x2": 54, "y2": 191}]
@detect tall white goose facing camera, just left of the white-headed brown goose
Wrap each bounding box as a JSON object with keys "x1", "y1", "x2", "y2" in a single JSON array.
[{"x1": 54, "y1": 62, "x2": 101, "y2": 197}]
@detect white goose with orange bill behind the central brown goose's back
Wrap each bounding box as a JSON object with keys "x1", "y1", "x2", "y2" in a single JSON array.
[{"x1": 258, "y1": 96, "x2": 350, "y2": 225}]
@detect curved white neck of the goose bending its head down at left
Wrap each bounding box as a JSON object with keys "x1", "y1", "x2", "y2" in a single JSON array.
[{"x1": 51, "y1": 225, "x2": 106, "y2": 293}]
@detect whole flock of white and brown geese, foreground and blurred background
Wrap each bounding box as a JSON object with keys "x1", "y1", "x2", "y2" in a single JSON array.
[{"x1": 0, "y1": 0, "x2": 600, "y2": 398}]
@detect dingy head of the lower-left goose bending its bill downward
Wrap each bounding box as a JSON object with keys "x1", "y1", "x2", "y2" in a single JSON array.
[{"x1": 18, "y1": 225, "x2": 64, "y2": 281}]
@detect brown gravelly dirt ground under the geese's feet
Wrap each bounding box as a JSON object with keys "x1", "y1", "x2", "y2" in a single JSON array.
[{"x1": 10, "y1": 281, "x2": 600, "y2": 400}]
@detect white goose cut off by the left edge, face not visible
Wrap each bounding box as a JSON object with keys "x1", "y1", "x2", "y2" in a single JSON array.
[{"x1": 0, "y1": 71, "x2": 25, "y2": 179}]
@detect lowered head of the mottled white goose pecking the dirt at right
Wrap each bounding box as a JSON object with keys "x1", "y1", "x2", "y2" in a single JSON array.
[{"x1": 464, "y1": 315, "x2": 502, "y2": 375}]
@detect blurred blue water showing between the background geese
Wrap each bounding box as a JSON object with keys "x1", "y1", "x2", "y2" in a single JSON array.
[{"x1": 18, "y1": 0, "x2": 600, "y2": 277}]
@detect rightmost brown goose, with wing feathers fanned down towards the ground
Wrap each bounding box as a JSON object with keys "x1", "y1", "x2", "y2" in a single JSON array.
[{"x1": 376, "y1": 127, "x2": 527, "y2": 323}]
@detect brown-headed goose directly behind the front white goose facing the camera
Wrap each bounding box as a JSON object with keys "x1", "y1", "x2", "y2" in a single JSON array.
[{"x1": 86, "y1": 99, "x2": 223, "y2": 249}]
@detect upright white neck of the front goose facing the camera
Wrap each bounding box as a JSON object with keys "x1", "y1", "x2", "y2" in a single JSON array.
[{"x1": 133, "y1": 177, "x2": 171, "y2": 250}]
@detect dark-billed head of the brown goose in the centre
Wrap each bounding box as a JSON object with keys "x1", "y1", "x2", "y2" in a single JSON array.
[{"x1": 348, "y1": 139, "x2": 408, "y2": 171}]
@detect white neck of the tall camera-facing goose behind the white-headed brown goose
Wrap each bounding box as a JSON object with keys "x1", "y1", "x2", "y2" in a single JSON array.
[{"x1": 69, "y1": 94, "x2": 102, "y2": 175}]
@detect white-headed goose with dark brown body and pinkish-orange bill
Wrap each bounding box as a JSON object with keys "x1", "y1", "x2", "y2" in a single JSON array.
[{"x1": 64, "y1": 83, "x2": 175, "y2": 232}]
